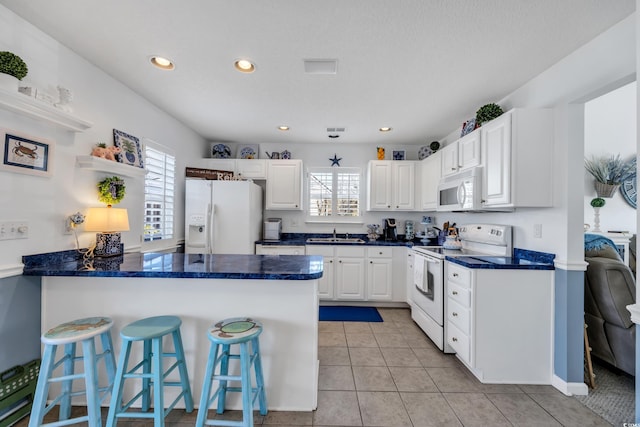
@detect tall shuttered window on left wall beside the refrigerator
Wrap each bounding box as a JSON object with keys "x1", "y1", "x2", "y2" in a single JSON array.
[{"x1": 144, "y1": 143, "x2": 176, "y2": 242}]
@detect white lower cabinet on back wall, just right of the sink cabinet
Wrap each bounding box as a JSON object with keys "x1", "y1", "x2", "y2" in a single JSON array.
[{"x1": 366, "y1": 246, "x2": 393, "y2": 301}]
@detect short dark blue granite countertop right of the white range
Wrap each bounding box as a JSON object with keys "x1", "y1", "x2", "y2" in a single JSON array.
[{"x1": 445, "y1": 248, "x2": 555, "y2": 270}]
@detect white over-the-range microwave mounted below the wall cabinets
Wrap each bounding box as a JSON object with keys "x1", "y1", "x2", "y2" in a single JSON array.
[{"x1": 437, "y1": 166, "x2": 482, "y2": 212}]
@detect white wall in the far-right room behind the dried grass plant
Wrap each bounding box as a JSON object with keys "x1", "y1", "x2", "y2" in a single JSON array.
[{"x1": 584, "y1": 82, "x2": 637, "y2": 234}]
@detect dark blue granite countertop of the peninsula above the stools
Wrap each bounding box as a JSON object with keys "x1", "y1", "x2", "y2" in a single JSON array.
[{"x1": 23, "y1": 251, "x2": 323, "y2": 280}]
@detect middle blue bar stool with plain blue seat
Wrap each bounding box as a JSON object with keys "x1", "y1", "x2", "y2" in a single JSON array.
[{"x1": 107, "y1": 316, "x2": 193, "y2": 427}]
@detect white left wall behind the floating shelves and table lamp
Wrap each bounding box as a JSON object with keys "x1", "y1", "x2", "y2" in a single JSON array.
[{"x1": 0, "y1": 6, "x2": 204, "y2": 270}]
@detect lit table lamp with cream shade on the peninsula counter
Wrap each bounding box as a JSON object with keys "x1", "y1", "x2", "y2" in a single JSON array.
[{"x1": 84, "y1": 205, "x2": 129, "y2": 257}]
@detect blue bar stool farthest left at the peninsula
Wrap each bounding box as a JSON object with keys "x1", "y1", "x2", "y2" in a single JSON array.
[{"x1": 29, "y1": 317, "x2": 116, "y2": 427}]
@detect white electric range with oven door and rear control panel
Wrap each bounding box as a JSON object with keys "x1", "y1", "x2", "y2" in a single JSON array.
[{"x1": 411, "y1": 224, "x2": 513, "y2": 353}]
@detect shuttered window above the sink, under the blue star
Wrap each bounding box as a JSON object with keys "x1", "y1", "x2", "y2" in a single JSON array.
[{"x1": 309, "y1": 168, "x2": 360, "y2": 220}]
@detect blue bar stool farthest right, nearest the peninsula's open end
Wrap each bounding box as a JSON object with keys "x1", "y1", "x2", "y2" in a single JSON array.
[{"x1": 196, "y1": 317, "x2": 267, "y2": 427}]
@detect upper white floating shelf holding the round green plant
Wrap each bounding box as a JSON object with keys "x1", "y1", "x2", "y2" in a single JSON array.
[{"x1": 0, "y1": 89, "x2": 93, "y2": 132}]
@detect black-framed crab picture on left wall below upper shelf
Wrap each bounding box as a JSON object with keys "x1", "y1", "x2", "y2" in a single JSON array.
[{"x1": 0, "y1": 129, "x2": 55, "y2": 176}]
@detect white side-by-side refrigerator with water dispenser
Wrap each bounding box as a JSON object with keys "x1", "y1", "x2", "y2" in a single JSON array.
[{"x1": 184, "y1": 179, "x2": 262, "y2": 254}]
